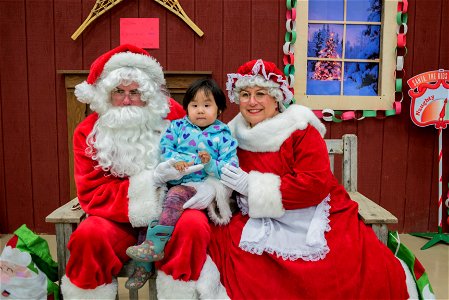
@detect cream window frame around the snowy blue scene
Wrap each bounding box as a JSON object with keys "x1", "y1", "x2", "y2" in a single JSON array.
[{"x1": 294, "y1": 0, "x2": 398, "y2": 110}]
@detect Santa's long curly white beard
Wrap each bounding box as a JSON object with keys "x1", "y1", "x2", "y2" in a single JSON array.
[{"x1": 86, "y1": 106, "x2": 166, "y2": 177}]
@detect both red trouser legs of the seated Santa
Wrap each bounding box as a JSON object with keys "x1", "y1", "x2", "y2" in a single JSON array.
[{"x1": 66, "y1": 209, "x2": 211, "y2": 289}]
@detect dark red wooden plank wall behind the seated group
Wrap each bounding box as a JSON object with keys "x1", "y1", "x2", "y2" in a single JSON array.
[{"x1": 0, "y1": 0, "x2": 449, "y2": 233}]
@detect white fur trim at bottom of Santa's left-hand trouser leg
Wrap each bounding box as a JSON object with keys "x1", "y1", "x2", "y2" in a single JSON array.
[{"x1": 61, "y1": 275, "x2": 117, "y2": 300}]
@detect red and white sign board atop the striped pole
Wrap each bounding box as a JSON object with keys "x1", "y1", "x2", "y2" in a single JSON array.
[{"x1": 407, "y1": 70, "x2": 449, "y2": 129}]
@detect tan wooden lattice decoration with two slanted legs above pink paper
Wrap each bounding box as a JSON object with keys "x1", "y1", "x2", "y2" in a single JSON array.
[{"x1": 72, "y1": 0, "x2": 204, "y2": 40}]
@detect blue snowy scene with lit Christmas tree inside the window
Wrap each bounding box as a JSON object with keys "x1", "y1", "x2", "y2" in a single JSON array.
[{"x1": 307, "y1": 0, "x2": 381, "y2": 96}]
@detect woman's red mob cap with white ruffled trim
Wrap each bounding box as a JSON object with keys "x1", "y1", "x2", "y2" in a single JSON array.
[{"x1": 226, "y1": 59, "x2": 293, "y2": 108}]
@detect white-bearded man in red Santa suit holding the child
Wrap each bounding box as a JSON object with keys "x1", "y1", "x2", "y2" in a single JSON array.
[{"x1": 61, "y1": 45, "x2": 212, "y2": 299}]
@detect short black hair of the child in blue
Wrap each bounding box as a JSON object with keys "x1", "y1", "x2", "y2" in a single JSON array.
[{"x1": 182, "y1": 78, "x2": 226, "y2": 114}]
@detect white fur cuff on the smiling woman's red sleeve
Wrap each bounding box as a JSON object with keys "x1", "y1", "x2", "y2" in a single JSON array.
[{"x1": 248, "y1": 171, "x2": 285, "y2": 218}]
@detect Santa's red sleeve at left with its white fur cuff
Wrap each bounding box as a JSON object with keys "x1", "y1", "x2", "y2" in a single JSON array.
[{"x1": 73, "y1": 113, "x2": 162, "y2": 227}]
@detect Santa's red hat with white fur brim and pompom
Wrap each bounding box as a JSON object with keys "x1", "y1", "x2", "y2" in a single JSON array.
[{"x1": 75, "y1": 44, "x2": 165, "y2": 104}]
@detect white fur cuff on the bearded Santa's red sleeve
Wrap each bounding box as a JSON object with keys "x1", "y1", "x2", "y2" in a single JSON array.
[{"x1": 128, "y1": 170, "x2": 164, "y2": 227}]
